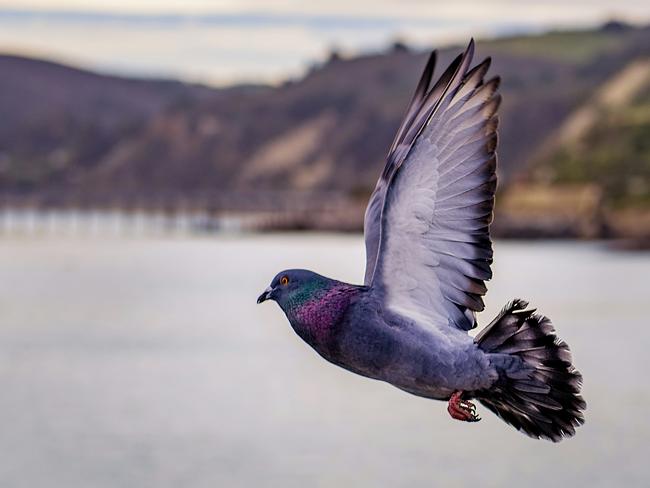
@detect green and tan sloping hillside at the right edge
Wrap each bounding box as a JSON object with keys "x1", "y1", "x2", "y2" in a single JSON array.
[{"x1": 532, "y1": 59, "x2": 650, "y2": 208}]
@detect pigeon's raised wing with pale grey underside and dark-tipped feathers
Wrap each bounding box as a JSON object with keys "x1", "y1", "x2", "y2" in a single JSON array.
[{"x1": 364, "y1": 41, "x2": 500, "y2": 330}]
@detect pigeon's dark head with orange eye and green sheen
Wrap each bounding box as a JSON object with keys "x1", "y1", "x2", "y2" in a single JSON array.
[{"x1": 257, "y1": 269, "x2": 332, "y2": 312}]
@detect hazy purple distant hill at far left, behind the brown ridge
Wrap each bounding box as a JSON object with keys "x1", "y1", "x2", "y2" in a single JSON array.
[{"x1": 0, "y1": 55, "x2": 220, "y2": 194}]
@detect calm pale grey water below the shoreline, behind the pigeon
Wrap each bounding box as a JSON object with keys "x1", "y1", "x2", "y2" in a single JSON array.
[{"x1": 0, "y1": 235, "x2": 650, "y2": 488}]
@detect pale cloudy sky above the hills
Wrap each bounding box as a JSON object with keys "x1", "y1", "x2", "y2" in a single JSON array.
[{"x1": 0, "y1": 0, "x2": 650, "y2": 85}]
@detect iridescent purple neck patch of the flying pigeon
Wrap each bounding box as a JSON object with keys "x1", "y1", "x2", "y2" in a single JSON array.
[{"x1": 285, "y1": 281, "x2": 360, "y2": 345}]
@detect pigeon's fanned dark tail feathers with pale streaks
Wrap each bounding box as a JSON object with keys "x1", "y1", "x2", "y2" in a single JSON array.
[{"x1": 475, "y1": 300, "x2": 587, "y2": 442}]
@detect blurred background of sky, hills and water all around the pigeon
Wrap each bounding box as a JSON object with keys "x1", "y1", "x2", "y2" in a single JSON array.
[{"x1": 0, "y1": 0, "x2": 650, "y2": 488}]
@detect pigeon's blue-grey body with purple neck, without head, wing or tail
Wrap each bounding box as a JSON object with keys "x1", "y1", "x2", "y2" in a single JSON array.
[{"x1": 287, "y1": 277, "x2": 497, "y2": 400}]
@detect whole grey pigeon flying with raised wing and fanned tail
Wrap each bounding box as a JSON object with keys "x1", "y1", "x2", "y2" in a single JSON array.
[{"x1": 257, "y1": 40, "x2": 586, "y2": 442}]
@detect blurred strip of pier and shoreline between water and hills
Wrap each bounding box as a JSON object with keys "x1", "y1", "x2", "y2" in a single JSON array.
[{"x1": 0, "y1": 208, "x2": 650, "y2": 251}]
